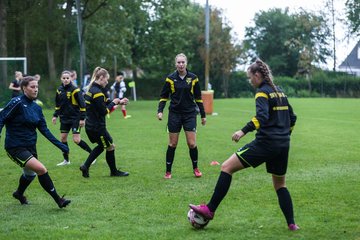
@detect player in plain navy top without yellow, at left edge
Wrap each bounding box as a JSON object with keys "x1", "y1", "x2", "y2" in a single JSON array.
[{"x1": 0, "y1": 76, "x2": 70, "y2": 208}]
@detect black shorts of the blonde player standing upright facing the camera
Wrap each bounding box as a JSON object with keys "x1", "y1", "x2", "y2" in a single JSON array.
[{"x1": 168, "y1": 111, "x2": 196, "y2": 133}]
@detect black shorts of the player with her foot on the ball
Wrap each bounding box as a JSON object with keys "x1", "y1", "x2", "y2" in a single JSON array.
[{"x1": 235, "y1": 140, "x2": 289, "y2": 176}]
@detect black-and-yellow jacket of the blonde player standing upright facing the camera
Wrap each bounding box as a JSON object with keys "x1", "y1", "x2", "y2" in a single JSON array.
[{"x1": 158, "y1": 71, "x2": 206, "y2": 118}]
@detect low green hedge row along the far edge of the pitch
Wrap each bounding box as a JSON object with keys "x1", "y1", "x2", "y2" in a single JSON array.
[{"x1": 0, "y1": 71, "x2": 360, "y2": 108}]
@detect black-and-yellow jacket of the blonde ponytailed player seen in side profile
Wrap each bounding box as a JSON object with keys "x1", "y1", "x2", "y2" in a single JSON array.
[{"x1": 85, "y1": 82, "x2": 115, "y2": 131}]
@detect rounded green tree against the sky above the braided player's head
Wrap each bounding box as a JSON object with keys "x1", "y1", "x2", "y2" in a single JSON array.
[{"x1": 244, "y1": 9, "x2": 331, "y2": 76}]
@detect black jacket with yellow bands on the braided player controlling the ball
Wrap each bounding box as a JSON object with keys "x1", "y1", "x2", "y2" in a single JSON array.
[{"x1": 242, "y1": 83, "x2": 296, "y2": 147}]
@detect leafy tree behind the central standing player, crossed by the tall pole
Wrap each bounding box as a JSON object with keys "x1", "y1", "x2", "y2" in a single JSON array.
[{"x1": 146, "y1": 0, "x2": 240, "y2": 97}]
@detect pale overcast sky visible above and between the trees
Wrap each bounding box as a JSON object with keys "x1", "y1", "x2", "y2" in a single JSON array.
[{"x1": 193, "y1": 0, "x2": 358, "y2": 69}]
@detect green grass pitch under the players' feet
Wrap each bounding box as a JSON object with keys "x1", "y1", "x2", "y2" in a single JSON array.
[{"x1": 0, "y1": 99, "x2": 360, "y2": 239}]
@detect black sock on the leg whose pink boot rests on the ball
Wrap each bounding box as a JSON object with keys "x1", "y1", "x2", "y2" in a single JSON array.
[{"x1": 207, "y1": 172, "x2": 232, "y2": 212}]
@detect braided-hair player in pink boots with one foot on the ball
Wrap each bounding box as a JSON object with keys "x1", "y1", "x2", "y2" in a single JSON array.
[{"x1": 190, "y1": 59, "x2": 299, "y2": 231}]
